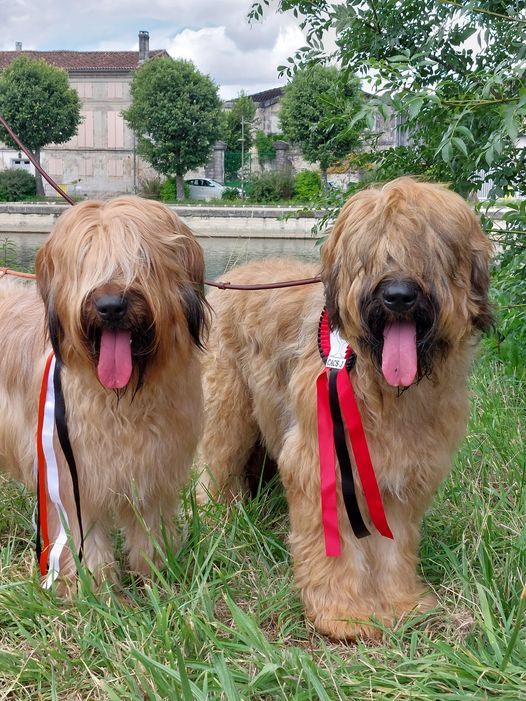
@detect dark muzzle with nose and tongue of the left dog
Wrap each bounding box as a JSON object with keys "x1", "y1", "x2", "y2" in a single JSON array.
[{"x1": 83, "y1": 295, "x2": 156, "y2": 394}]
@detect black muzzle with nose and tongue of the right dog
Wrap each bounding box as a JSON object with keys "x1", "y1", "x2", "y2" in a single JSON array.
[{"x1": 359, "y1": 279, "x2": 448, "y2": 388}]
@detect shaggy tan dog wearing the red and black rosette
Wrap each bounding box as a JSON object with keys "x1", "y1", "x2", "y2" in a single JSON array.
[{"x1": 199, "y1": 178, "x2": 491, "y2": 638}]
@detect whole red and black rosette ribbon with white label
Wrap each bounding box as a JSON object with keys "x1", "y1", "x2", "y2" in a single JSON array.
[{"x1": 316, "y1": 309, "x2": 393, "y2": 557}]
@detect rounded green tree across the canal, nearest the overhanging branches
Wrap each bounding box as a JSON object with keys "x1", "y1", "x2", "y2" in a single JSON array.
[{"x1": 279, "y1": 65, "x2": 361, "y2": 180}]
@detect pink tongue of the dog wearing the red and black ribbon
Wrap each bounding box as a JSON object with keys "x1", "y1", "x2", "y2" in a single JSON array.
[{"x1": 382, "y1": 321, "x2": 417, "y2": 387}]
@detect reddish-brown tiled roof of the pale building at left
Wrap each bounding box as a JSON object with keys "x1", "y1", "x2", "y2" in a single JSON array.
[{"x1": 0, "y1": 49, "x2": 168, "y2": 72}]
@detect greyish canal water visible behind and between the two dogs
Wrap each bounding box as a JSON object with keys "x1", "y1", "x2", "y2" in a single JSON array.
[{"x1": 0, "y1": 232, "x2": 319, "y2": 280}]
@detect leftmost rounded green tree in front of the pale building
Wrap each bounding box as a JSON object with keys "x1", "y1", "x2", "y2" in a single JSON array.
[{"x1": 0, "y1": 56, "x2": 81, "y2": 195}]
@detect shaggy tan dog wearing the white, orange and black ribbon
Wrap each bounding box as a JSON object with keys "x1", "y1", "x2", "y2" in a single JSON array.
[{"x1": 0, "y1": 197, "x2": 207, "y2": 586}]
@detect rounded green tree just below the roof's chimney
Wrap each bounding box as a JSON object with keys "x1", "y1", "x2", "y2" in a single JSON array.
[{"x1": 124, "y1": 57, "x2": 222, "y2": 199}]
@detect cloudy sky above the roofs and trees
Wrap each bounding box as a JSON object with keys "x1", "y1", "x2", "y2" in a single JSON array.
[{"x1": 0, "y1": 0, "x2": 305, "y2": 99}]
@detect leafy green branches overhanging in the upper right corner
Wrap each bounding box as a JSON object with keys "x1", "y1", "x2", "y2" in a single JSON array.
[{"x1": 251, "y1": 0, "x2": 526, "y2": 195}]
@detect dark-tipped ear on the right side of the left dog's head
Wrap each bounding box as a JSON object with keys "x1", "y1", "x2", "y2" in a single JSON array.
[{"x1": 181, "y1": 231, "x2": 210, "y2": 348}]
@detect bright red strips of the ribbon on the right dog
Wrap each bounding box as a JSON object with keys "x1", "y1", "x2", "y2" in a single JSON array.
[{"x1": 316, "y1": 309, "x2": 393, "y2": 557}]
